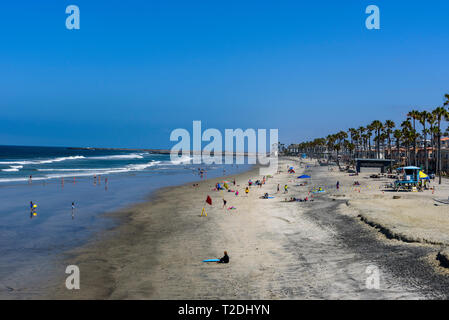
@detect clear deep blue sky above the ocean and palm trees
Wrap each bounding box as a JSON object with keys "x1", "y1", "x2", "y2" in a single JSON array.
[{"x1": 0, "y1": 0, "x2": 449, "y2": 148}]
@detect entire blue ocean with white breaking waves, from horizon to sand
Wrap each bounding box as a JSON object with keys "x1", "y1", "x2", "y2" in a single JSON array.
[{"x1": 0, "y1": 146, "x2": 250, "y2": 298}]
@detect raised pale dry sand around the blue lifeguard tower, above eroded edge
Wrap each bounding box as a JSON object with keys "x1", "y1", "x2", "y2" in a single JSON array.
[{"x1": 330, "y1": 166, "x2": 449, "y2": 246}]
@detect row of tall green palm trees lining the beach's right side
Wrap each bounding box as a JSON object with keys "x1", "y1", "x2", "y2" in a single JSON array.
[{"x1": 297, "y1": 94, "x2": 449, "y2": 183}]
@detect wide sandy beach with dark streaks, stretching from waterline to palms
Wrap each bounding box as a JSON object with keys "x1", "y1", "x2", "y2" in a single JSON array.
[{"x1": 29, "y1": 158, "x2": 449, "y2": 299}]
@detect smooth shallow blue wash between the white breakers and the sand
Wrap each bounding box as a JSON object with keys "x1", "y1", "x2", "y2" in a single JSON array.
[{"x1": 0, "y1": 160, "x2": 252, "y2": 299}]
